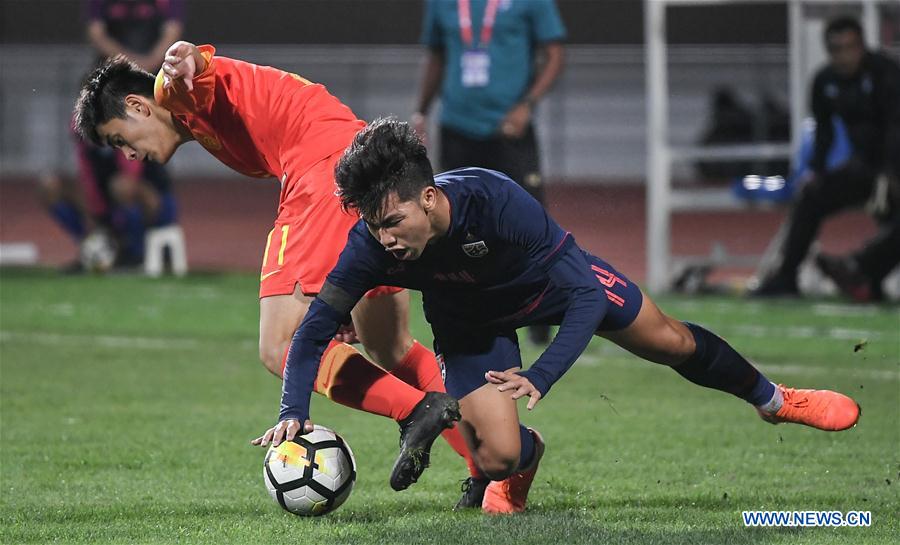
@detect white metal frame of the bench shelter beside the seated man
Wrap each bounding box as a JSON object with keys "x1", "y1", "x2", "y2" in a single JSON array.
[{"x1": 644, "y1": 0, "x2": 897, "y2": 292}]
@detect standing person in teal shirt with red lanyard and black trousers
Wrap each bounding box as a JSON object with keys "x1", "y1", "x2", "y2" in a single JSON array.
[{"x1": 412, "y1": 0, "x2": 566, "y2": 344}]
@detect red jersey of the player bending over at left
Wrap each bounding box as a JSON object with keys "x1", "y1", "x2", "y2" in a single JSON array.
[{"x1": 154, "y1": 45, "x2": 365, "y2": 181}]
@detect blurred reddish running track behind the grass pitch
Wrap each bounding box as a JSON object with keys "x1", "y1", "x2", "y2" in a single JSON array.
[{"x1": 0, "y1": 179, "x2": 875, "y2": 281}]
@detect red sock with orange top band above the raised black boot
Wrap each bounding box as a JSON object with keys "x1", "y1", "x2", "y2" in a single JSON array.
[{"x1": 316, "y1": 341, "x2": 425, "y2": 420}]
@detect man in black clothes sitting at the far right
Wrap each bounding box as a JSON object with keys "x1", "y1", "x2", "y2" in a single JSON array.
[{"x1": 750, "y1": 17, "x2": 900, "y2": 301}]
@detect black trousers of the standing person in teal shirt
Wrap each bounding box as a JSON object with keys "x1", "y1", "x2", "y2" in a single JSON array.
[{"x1": 440, "y1": 125, "x2": 544, "y2": 204}]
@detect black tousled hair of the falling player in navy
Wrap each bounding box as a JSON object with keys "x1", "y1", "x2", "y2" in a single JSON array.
[{"x1": 334, "y1": 117, "x2": 434, "y2": 219}]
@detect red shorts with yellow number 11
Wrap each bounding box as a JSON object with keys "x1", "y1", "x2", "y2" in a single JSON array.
[{"x1": 259, "y1": 152, "x2": 402, "y2": 298}]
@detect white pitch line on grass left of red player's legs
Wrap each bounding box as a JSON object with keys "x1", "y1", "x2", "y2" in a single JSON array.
[{"x1": 0, "y1": 331, "x2": 255, "y2": 351}]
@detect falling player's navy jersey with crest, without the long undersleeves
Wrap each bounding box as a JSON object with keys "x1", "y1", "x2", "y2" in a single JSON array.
[{"x1": 327, "y1": 168, "x2": 574, "y2": 325}]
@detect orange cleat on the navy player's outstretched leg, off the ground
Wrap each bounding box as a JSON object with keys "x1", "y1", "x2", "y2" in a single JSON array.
[{"x1": 757, "y1": 384, "x2": 860, "y2": 431}]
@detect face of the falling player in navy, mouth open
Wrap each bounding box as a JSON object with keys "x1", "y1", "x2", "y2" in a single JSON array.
[{"x1": 364, "y1": 188, "x2": 434, "y2": 261}]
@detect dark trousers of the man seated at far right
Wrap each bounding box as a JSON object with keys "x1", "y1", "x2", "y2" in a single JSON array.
[{"x1": 778, "y1": 160, "x2": 900, "y2": 282}]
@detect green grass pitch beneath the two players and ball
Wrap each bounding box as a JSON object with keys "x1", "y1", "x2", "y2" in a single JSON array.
[{"x1": 0, "y1": 270, "x2": 900, "y2": 545}]
